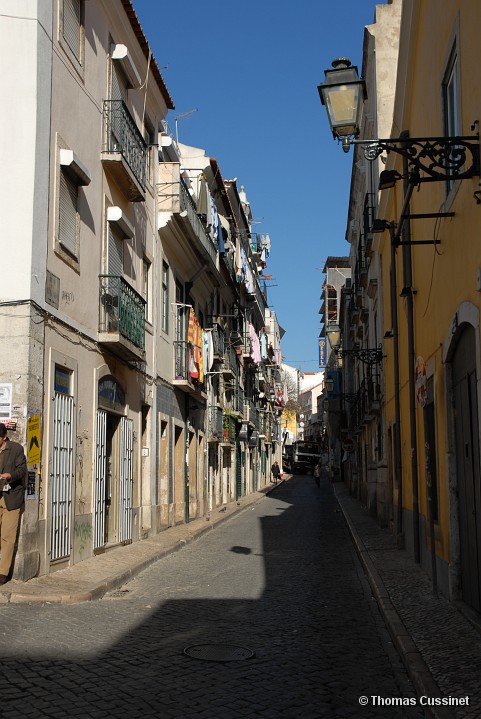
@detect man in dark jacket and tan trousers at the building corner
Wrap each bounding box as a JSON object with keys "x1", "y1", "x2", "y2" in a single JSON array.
[{"x1": 0, "y1": 423, "x2": 27, "y2": 584}]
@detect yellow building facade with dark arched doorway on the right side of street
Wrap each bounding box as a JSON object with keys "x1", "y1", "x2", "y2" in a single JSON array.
[{"x1": 374, "y1": 0, "x2": 481, "y2": 612}]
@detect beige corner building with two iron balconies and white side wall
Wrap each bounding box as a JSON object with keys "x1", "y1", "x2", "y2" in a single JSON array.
[{"x1": 0, "y1": 0, "x2": 173, "y2": 579}]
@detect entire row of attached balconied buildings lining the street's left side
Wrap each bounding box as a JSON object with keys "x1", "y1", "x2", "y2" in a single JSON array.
[{"x1": 0, "y1": 0, "x2": 281, "y2": 579}]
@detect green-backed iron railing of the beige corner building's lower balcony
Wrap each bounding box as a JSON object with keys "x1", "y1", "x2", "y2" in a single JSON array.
[{"x1": 99, "y1": 275, "x2": 145, "y2": 349}]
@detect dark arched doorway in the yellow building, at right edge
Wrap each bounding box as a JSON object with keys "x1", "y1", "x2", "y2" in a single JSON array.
[{"x1": 452, "y1": 324, "x2": 481, "y2": 612}]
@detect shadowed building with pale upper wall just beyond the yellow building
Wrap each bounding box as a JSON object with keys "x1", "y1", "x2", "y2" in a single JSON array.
[{"x1": 341, "y1": 0, "x2": 402, "y2": 526}]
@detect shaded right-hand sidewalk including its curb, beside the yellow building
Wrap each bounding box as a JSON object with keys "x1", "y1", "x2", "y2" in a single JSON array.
[{"x1": 333, "y1": 483, "x2": 481, "y2": 719}]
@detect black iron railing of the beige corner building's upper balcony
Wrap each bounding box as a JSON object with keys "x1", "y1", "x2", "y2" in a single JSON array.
[{"x1": 104, "y1": 100, "x2": 147, "y2": 190}]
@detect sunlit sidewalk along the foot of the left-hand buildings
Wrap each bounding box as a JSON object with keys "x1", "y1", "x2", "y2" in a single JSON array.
[{"x1": 0, "y1": 478, "x2": 285, "y2": 604}]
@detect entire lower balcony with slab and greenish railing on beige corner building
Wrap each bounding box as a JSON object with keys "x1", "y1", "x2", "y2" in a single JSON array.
[{"x1": 99, "y1": 275, "x2": 145, "y2": 362}]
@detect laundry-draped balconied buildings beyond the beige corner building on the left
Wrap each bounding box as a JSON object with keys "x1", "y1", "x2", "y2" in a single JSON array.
[{"x1": 158, "y1": 131, "x2": 280, "y2": 522}]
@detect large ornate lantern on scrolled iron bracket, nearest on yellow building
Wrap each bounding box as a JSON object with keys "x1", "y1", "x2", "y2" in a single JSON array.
[{"x1": 317, "y1": 58, "x2": 479, "y2": 180}]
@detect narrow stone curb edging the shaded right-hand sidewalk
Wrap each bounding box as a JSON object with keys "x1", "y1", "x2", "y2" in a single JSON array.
[{"x1": 334, "y1": 487, "x2": 455, "y2": 719}]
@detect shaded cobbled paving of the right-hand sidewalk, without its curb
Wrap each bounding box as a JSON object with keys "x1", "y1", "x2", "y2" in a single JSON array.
[{"x1": 334, "y1": 484, "x2": 481, "y2": 719}]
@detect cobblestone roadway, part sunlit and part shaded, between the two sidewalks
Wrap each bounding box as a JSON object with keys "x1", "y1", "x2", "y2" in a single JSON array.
[{"x1": 0, "y1": 477, "x2": 425, "y2": 719}]
